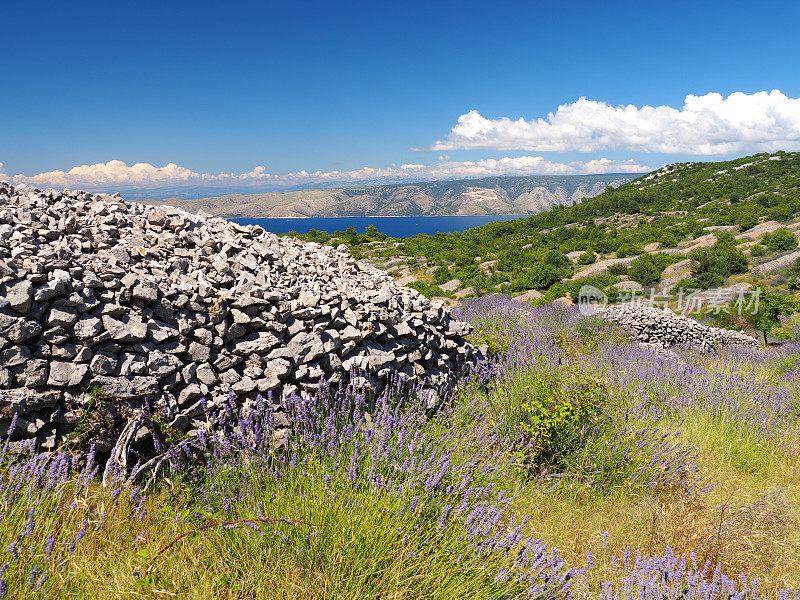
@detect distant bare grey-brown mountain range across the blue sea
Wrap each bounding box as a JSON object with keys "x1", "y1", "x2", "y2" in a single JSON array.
[{"x1": 144, "y1": 173, "x2": 637, "y2": 218}]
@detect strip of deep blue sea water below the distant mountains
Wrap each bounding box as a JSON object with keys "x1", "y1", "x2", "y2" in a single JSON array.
[{"x1": 232, "y1": 215, "x2": 522, "y2": 238}]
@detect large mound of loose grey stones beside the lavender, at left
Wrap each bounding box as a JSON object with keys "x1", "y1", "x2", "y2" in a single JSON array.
[{"x1": 0, "y1": 182, "x2": 477, "y2": 452}]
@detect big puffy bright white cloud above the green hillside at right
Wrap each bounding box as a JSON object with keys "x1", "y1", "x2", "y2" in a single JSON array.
[{"x1": 430, "y1": 90, "x2": 800, "y2": 155}]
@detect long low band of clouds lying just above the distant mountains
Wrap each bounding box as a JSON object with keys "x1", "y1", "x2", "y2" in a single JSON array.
[{"x1": 6, "y1": 156, "x2": 653, "y2": 190}]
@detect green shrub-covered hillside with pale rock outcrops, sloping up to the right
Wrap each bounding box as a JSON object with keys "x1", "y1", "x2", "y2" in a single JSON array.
[{"x1": 290, "y1": 152, "x2": 800, "y2": 336}]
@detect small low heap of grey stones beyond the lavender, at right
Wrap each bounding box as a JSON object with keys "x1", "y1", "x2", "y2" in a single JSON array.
[{"x1": 602, "y1": 303, "x2": 758, "y2": 351}]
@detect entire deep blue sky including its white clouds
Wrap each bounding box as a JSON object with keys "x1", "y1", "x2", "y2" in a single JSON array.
[{"x1": 0, "y1": 0, "x2": 800, "y2": 188}]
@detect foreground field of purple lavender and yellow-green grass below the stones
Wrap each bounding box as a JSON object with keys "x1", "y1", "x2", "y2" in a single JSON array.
[{"x1": 0, "y1": 297, "x2": 800, "y2": 600}]
